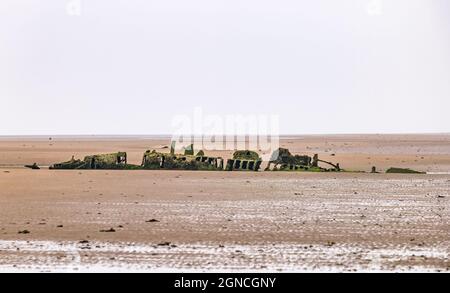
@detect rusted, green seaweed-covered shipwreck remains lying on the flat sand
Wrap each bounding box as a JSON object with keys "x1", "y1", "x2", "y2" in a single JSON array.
[{"x1": 47, "y1": 142, "x2": 343, "y2": 172}]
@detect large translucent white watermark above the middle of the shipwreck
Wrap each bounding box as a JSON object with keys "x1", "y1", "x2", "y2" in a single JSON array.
[{"x1": 172, "y1": 107, "x2": 280, "y2": 161}]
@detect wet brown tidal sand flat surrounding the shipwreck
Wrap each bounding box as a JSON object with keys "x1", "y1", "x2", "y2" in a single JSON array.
[{"x1": 0, "y1": 135, "x2": 450, "y2": 272}]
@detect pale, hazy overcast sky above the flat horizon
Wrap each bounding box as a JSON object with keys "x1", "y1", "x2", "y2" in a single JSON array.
[{"x1": 0, "y1": 0, "x2": 450, "y2": 135}]
